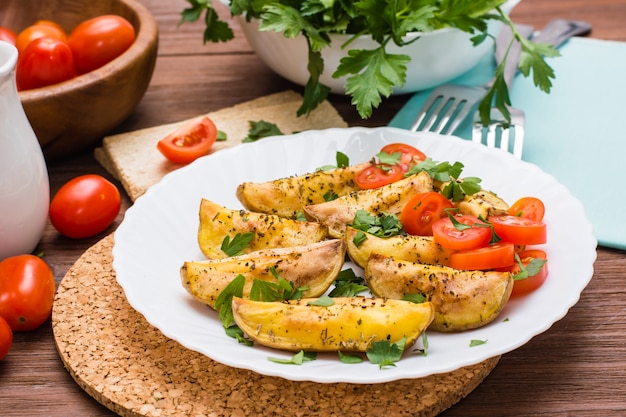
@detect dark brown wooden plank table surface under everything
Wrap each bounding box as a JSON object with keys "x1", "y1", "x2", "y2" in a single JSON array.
[{"x1": 0, "y1": 0, "x2": 626, "y2": 417}]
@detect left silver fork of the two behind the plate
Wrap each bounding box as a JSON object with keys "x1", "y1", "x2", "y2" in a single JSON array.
[{"x1": 410, "y1": 25, "x2": 533, "y2": 135}]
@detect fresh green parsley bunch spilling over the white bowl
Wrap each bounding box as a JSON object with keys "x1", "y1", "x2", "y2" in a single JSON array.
[{"x1": 181, "y1": 0, "x2": 558, "y2": 124}]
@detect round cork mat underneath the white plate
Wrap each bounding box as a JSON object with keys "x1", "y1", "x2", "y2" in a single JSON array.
[{"x1": 52, "y1": 236, "x2": 500, "y2": 417}]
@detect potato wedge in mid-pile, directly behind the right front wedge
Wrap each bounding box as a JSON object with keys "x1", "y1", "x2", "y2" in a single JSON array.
[{"x1": 345, "y1": 226, "x2": 453, "y2": 268}]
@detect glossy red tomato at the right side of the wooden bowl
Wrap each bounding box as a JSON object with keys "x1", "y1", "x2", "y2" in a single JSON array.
[{"x1": 68, "y1": 15, "x2": 135, "y2": 74}]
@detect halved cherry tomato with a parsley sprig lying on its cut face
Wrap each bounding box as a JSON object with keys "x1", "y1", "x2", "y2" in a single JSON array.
[{"x1": 433, "y1": 214, "x2": 491, "y2": 250}]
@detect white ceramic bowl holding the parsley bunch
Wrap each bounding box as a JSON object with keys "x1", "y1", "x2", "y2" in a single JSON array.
[{"x1": 232, "y1": 0, "x2": 520, "y2": 94}]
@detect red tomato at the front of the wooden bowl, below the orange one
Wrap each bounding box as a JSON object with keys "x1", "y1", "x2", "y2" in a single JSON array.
[{"x1": 15, "y1": 38, "x2": 75, "y2": 91}]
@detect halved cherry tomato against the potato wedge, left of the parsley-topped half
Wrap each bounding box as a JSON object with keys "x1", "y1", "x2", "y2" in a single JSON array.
[{"x1": 400, "y1": 191, "x2": 454, "y2": 236}]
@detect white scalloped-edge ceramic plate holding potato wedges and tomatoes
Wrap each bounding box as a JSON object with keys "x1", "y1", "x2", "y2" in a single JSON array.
[{"x1": 113, "y1": 128, "x2": 596, "y2": 383}]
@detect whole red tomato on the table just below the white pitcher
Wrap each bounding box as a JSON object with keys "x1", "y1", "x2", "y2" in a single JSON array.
[{"x1": 0, "y1": 255, "x2": 55, "y2": 331}]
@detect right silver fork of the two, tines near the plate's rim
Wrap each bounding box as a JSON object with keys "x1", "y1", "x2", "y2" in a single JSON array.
[{"x1": 472, "y1": 19, "x2": 591, "y2": 159}]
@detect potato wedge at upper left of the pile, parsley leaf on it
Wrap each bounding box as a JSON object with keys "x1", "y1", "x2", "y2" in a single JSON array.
[{"x1": 198, "y1": 199, "x2": 328, "y2": 259}]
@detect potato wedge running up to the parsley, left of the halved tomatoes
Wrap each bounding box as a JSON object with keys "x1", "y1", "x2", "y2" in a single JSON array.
[{"x1": 304, "y1": 172, "x2": 433, "y2": 238}]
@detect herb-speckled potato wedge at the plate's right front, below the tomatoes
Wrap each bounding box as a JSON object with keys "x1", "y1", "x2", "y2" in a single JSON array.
[{"x1": 364, "y1": 254, "x2": 513, "y2": 332}]
